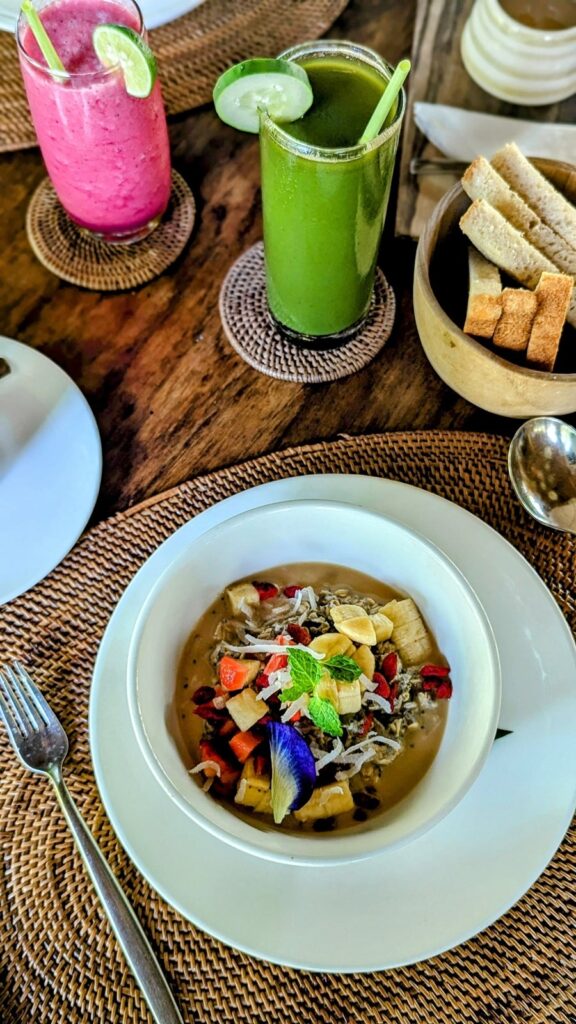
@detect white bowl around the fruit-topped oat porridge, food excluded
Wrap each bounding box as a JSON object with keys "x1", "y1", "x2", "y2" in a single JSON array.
[{"x1": 128, "y1": 501, "x2": 500, "y2": 864}]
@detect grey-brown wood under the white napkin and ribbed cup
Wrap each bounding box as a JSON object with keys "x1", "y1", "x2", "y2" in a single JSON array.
[{"x1": 396, "y1": 0, "x2": 576, "y2": 238}]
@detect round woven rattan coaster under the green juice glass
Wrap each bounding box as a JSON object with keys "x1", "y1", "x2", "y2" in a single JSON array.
[{"x1": 219, "y1": 242, "x2": 396, "y2": 384}]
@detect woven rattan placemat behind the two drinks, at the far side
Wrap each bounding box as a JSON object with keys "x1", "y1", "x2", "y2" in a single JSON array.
[{"x1": 0, "y1": 0, "x2": 347, "y2": 153}]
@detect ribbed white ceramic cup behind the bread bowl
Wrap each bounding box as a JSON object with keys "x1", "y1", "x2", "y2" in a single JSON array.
[{"x1": 460, "y1": 0, "x2": 576, "y2": 106}]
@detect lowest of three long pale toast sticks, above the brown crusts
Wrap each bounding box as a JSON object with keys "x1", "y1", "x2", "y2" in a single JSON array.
[{"x1": 460, "y1": 199, "x2": 576, "y2": 327}]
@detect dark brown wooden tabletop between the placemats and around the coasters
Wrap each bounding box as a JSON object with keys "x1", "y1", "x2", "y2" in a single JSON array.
[{"x1": 0, "y1": 0, "x2": 565, "y2": 521}]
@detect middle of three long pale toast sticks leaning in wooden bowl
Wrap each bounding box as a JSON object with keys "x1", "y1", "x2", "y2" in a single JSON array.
[{"x1": 461, "y1": 151, "x2": 576, "y2": 278}]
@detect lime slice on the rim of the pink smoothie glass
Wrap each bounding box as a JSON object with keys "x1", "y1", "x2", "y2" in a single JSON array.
[{"x1": 92, "y1": 25, "x2": 157, "y2": 99}]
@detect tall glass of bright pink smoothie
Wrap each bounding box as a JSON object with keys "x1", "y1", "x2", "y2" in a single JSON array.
[{"x1": 19, "y1": 0, "x2": 170, "y2": 236}]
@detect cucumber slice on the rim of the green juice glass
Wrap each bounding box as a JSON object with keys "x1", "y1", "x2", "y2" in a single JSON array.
[{"x1": 213, "y1": 57, "x2": 314, "y2": 132}]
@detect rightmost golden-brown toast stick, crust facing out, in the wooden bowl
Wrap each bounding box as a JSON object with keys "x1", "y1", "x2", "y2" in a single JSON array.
[{"x1": 526, "y1": 272, "x2": 574, "y2": 371}]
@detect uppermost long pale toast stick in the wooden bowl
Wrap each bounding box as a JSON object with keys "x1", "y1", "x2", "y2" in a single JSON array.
[{"x1": 491, "y1": 142, "x2": 576, "y2": 249}]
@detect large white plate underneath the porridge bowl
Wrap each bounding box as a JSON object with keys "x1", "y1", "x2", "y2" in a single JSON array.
[{"x1": 90, "y1": 475, "x2": 576, "y2": 972}]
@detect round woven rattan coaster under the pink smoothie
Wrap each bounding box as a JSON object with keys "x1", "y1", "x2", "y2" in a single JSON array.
[{"x1": 26, "y1": 170, "x2": 196, "y2": 292}]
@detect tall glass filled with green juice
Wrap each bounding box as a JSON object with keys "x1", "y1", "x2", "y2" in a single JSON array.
[{"x1": 260, "y1": 40, "x2": 405, "y2": 348}]
